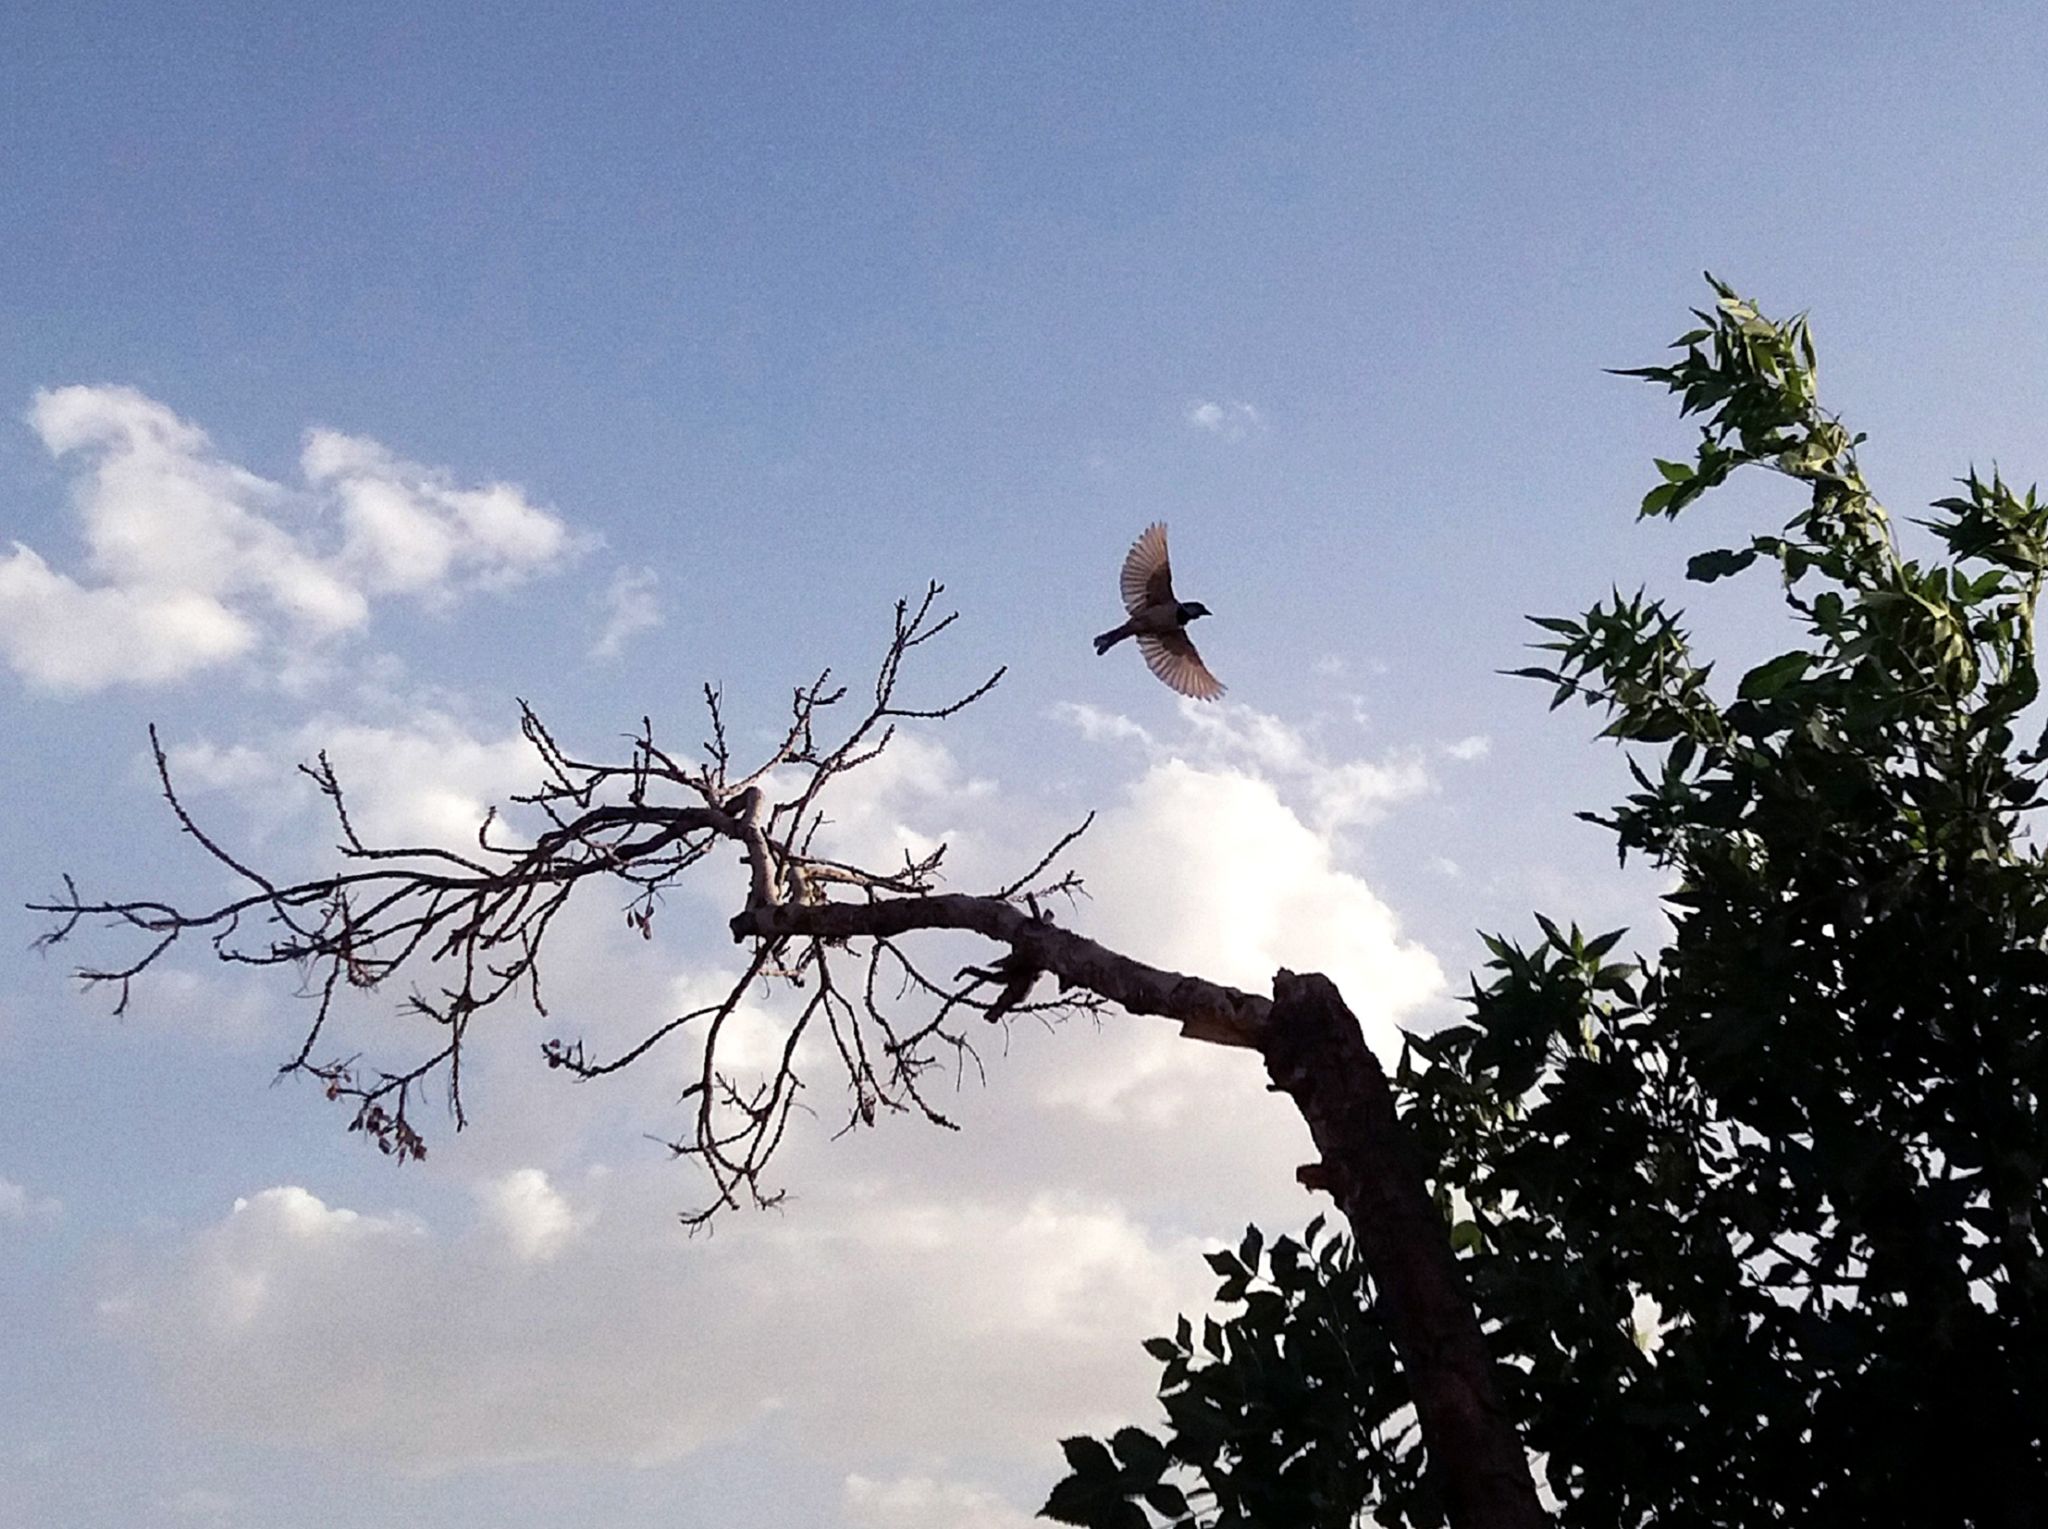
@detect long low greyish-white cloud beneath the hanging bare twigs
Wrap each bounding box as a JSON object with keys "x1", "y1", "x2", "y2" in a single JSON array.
[{"x1": 100, "y1": 1179, "x2": 1206, "y2": 1472}]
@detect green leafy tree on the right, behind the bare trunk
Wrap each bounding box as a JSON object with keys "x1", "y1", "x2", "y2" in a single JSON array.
[{"x1": 1044, "y1": 282, "x2": 2048, "y2": 1529}]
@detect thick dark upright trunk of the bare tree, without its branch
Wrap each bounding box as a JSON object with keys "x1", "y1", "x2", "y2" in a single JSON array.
[{"x1": 1260, "y1": 970, "x2": 1550, "y2": 1529}]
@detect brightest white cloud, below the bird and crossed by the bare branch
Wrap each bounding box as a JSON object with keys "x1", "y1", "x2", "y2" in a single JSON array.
[{"x1": 1040, "y1": 704, "x2": 1446, "y2": 1129}]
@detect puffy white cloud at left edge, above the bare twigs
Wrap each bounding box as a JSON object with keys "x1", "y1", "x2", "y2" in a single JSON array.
[{"x1": 0, "y1": 385, "x2": 571, "y2": 694}]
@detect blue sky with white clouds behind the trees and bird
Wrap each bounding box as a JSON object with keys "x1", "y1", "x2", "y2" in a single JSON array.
[{"x1": 0, "y1": 0, "x2": 2048, "y2": 1529}]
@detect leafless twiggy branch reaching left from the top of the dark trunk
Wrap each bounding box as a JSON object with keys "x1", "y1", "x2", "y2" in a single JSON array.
[{"x1": 33, "y1": 583, "x2": 1270, "y2": 1220}]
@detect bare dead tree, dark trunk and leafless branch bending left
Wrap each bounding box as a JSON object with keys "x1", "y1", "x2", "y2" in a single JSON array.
[{"x1": 31, "y1": 583, "x2": 1542, "y2": 1527}]
